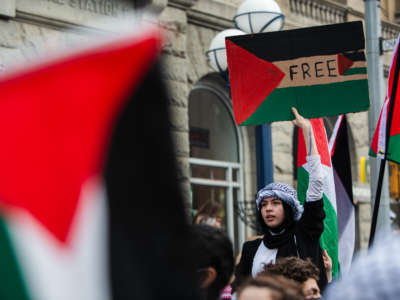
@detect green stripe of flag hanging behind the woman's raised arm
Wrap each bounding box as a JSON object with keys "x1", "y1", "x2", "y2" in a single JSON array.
[{"x1": 297, "y1": 167, "x2": 339, "y2": 278}]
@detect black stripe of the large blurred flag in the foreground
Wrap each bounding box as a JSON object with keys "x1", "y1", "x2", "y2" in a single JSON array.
[{"x1": 105, "y1": 62, "x2": 202, "y2": 300}]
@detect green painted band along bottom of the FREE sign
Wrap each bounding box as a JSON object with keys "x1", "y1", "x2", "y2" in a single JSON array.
[{"x1": 240, "y1": 79, "x2": 369, "y2": 125}]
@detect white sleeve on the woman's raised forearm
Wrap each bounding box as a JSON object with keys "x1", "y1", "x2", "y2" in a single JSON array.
[{"x1": 306, "y1": 155, "x2": 325, "y2": 202}]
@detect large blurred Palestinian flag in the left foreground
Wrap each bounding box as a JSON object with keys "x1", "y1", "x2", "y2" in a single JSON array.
[{"x1": 0, "y1": 28, "x2": 197, "y2": 300}]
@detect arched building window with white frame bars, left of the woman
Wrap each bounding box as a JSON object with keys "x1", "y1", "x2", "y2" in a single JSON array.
[{"x1": 189, "y1": 77, "x2": 244, "y2": 249}]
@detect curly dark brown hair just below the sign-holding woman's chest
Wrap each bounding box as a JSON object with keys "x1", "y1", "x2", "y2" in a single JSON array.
[{"x1": 261, "y1": 256, "x2": 319, "y2": 283}]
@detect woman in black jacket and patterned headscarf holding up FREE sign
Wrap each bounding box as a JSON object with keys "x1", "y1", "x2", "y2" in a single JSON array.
[{"x1": 232, "y1": 107, "x2": 327, "y2": 290}]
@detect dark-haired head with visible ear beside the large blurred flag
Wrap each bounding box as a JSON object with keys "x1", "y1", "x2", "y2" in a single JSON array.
[{"x1": 190, "y1": 224, "x2": 234, "y2": 300}]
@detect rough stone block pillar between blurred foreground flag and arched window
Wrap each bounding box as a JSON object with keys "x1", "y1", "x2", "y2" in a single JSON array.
[{"x1": 160, "y1": 0, "x2": 197, "y2": 213}]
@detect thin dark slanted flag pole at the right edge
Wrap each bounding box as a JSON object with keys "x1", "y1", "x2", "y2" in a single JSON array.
[{"x1": 368, "y1": 38, "x2": 400, "y2": 248}]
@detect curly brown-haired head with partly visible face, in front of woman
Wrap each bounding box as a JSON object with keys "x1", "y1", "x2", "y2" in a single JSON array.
[{"x1": 261, "y1": 257, "x2": 321, "y2": 299}]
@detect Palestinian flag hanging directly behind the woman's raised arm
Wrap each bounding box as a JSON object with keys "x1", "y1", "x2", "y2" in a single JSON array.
[{"x1": 297, "y1": 119, "x2": 339, "y2": 276}]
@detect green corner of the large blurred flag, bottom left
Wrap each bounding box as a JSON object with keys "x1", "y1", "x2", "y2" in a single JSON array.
[{"x1": 0, "y1": 218, "x2": 29, "y2": 300}]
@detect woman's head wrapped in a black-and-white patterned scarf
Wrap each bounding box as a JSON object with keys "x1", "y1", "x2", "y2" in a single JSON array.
[{"x1": 256, "y1": 182, "x2": 303, "y2": 231}]
